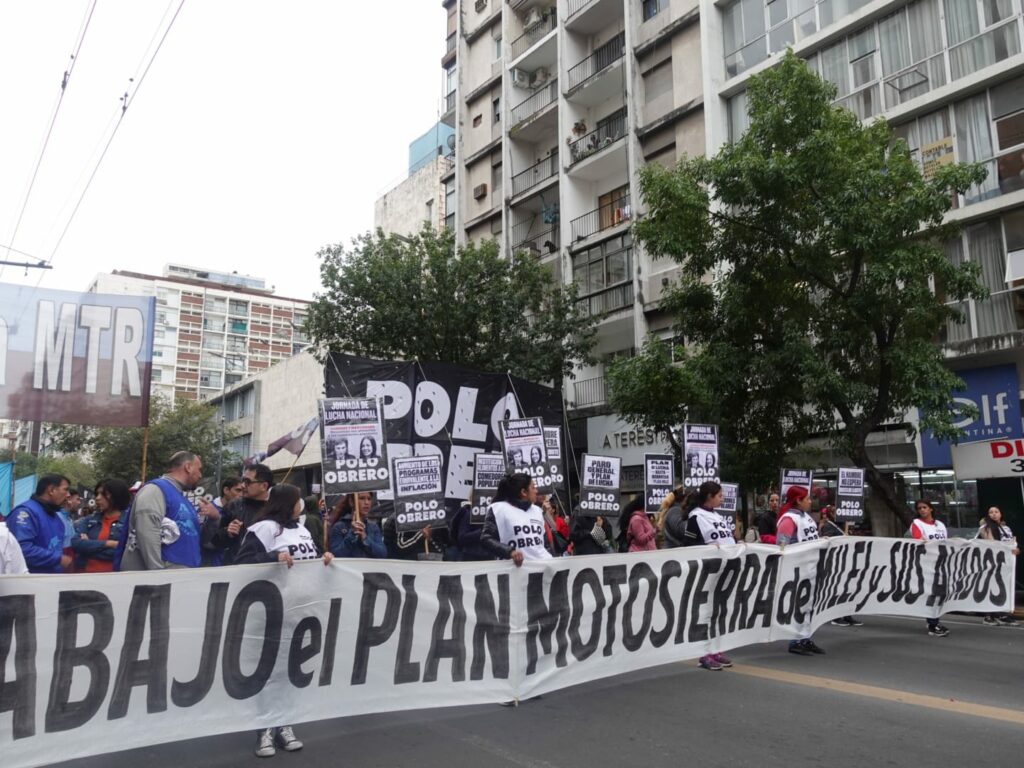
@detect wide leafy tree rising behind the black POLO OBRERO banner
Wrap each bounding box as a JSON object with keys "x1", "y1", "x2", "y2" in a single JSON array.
[{"x1": 305, "y1": 228, "x2": 595, "y2": 382}]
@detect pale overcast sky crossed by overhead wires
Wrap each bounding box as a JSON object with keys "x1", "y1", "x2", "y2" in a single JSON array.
[{"x1": 0, "y1": 0, "x2": 444, "y2": 298}]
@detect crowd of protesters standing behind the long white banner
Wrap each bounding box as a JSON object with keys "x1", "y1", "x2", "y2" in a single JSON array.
[{"x1": 0, "y1": 451, "x2": 1019, "y2": 757}]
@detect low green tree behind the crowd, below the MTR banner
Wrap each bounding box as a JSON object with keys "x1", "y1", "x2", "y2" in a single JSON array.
[{"x1": 88, "y1": 397, "x2": 239, "y2": 483}]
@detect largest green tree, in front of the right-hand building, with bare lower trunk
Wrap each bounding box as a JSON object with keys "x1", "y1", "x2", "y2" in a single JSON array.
[{"x1": 610, "y1": 52, "x2": 984, "y2": 522}]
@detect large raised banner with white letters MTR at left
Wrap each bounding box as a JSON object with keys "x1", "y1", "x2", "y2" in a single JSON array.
[{"x1": 0, "y1": 284, "x2": 156, "y2": 427}]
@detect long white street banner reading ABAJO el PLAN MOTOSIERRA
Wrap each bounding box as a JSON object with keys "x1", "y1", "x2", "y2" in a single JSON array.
[{"x1": 0, "y1": 537, "x2": 1015, "y2": 768}]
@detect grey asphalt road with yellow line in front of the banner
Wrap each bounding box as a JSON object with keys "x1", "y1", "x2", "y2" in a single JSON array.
[{"x1": 49, "y1": 616, "x2": 1024, "y2": 768}]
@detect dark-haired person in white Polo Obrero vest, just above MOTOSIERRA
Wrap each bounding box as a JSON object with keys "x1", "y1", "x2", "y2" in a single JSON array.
[{"x1": 480, "y1": 473, "x2": 551, "y2": 566}]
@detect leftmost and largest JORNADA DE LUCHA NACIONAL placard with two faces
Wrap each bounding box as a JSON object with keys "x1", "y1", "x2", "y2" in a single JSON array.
[{"x1": 319, "y1": 397, "x2": 391, "y2": 505}]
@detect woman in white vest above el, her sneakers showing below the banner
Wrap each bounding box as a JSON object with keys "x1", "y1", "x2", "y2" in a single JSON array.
[{"x1": 234, "y1": 483, "x2": 334, "y2": 758}]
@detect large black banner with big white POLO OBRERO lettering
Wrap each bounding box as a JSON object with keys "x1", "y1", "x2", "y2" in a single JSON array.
[{"x1": 325, "y1": 353, "x2": 563, "y2": 514}]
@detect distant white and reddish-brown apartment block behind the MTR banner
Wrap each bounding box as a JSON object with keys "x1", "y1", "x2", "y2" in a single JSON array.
[{"x1": 88, "y1": 264, "x2": 309, "y2": 400}]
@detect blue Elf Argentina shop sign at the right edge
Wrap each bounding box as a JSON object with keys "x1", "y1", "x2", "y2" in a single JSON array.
[{"x1": 921, "y1": 365, "x2": 1021, "y2": 467}]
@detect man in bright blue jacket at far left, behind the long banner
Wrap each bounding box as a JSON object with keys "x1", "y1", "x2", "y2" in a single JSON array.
[{"x1": 7, "y1": 475, "x2": 72, "y2": 573}]
